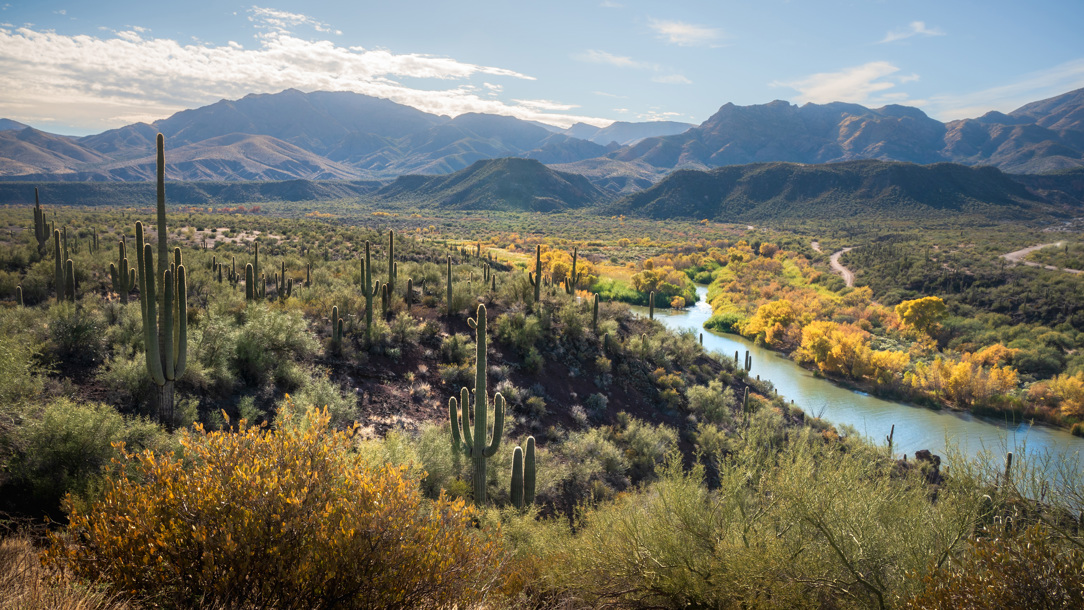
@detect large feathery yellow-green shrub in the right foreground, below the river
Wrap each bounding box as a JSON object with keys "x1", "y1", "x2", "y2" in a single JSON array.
[{"x1": 550, "y1": 430, "x2": 981, "y2": 608}]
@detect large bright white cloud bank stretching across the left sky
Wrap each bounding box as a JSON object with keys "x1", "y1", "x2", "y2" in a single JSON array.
[{"x1": 0, "y1": 21, "x2": 608, "y2": 132}]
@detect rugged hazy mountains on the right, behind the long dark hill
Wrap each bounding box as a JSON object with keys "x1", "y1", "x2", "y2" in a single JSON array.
[{"x1": 607, "y1": 90, "x2": 1084, "y2": 173}]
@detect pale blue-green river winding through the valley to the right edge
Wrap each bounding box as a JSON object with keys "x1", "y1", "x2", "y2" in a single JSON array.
[{"x1": 633, "y1": 286, "x2": 1084, "y2": 473}]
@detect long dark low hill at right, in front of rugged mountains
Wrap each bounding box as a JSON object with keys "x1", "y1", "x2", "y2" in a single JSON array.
[{"x1": 605, "y1": 160, "x2": 1066, "y2": 222}]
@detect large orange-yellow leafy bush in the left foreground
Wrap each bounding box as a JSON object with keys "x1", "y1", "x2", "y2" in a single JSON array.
[{"x1": 49, "y1": 405, "x2": 503, "y2": 608}]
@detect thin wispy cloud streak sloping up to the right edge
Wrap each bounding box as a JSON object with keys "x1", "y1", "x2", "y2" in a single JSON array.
[{"x1": 927, "y1": 57, "x2": 1084, "y2": 120}]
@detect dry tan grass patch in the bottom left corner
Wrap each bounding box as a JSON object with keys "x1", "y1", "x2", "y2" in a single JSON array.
[{"x1": 0, "y1": 533, "x2": 138, "y2": 610}]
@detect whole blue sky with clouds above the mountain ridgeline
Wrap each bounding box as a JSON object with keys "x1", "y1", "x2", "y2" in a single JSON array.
[{"x1": 0, "y1": 0, "x2": 1084, "y2": 135}]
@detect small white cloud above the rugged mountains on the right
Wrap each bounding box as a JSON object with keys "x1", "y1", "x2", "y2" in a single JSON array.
[{"x1": 772, "y1": 62, "x2": 916, "y2": 105}]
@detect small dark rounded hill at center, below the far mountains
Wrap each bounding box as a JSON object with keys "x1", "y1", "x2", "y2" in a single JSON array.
[{"x1": 376, "y1": 158, "x2": 607, "y2": 211}]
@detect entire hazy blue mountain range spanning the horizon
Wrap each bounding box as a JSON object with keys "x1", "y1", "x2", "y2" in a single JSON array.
[{"x1": 0, "y1": 89, "x2": 1084, "y2": 185}]
